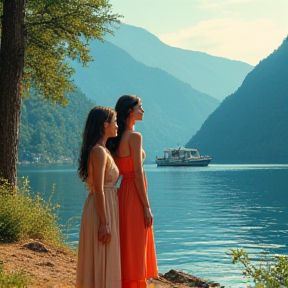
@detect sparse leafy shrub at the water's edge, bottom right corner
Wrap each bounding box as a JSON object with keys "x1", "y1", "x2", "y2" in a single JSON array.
[{"x1": 231, "y1": 249, "x2": 288, "y2": 288}]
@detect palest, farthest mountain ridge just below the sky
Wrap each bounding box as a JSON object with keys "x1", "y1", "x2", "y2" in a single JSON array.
[{"x1": 105, "y1": 24, "x2": 253, "y2": 101}]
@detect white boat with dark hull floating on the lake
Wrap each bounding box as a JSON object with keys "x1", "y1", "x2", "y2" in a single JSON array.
[{"x1": 156, "y1": 147, "x2": 212, "y2": 166}]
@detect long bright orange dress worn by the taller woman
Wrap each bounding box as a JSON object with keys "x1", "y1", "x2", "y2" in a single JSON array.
[{"x1": 114, "y1": 156, "x2": 158, "y2": 288}]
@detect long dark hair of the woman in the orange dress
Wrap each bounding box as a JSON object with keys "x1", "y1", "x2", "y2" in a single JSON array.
[{"x1": 106, "y1": 95, "x2": 141, "y2": 155}]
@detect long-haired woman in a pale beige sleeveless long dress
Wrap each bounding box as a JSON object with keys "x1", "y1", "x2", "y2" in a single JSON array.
[{"x1": 76, "y1": 107, "x2": 121, "y2": 288}]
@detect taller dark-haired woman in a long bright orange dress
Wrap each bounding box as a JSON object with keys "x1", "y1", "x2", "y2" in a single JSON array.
[{"x1": 107, "y1": 95, "x2": 158, "y2": 288}]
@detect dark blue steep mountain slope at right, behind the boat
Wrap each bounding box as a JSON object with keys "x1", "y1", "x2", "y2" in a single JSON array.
[{"x1": 186, "y1": 38, "x2": 288, "y2": 164}]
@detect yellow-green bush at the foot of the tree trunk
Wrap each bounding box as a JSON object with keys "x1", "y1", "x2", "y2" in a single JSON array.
[{"x1": 0, "y1": 178, "x2": 64, "y2": 247}]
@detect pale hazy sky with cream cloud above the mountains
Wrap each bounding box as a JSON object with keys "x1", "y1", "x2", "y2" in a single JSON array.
[{"x1": 110, "y1": 0, "x2": 288, "y2": 65}]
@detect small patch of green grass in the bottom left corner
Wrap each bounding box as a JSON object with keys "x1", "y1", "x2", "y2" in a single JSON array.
[{"x1": 0, "y1": 261, "x2": 31, "y2": 288}]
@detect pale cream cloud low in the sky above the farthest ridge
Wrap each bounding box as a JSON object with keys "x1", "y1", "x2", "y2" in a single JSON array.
[{"x1": 157, "y1": 18, "x2": 288, "y2": 65}]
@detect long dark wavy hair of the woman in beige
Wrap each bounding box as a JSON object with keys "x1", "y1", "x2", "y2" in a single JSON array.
[{"x1": 78, "y1": 106, "x2": 116, "y2": 182}]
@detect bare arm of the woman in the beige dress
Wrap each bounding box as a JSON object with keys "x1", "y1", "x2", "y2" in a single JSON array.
[{"x1": 91, "y1": 146, "x2": 111, "y2": 242}]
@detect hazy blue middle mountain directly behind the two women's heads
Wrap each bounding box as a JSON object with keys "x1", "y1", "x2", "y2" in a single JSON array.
[{"x1": 72, "y1": 41, "x2": 219, "y2": 161}]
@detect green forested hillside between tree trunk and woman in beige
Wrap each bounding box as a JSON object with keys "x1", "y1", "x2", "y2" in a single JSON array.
[{"x1": 19, "y1": 89, "x2": 94, "y2": 163}]
